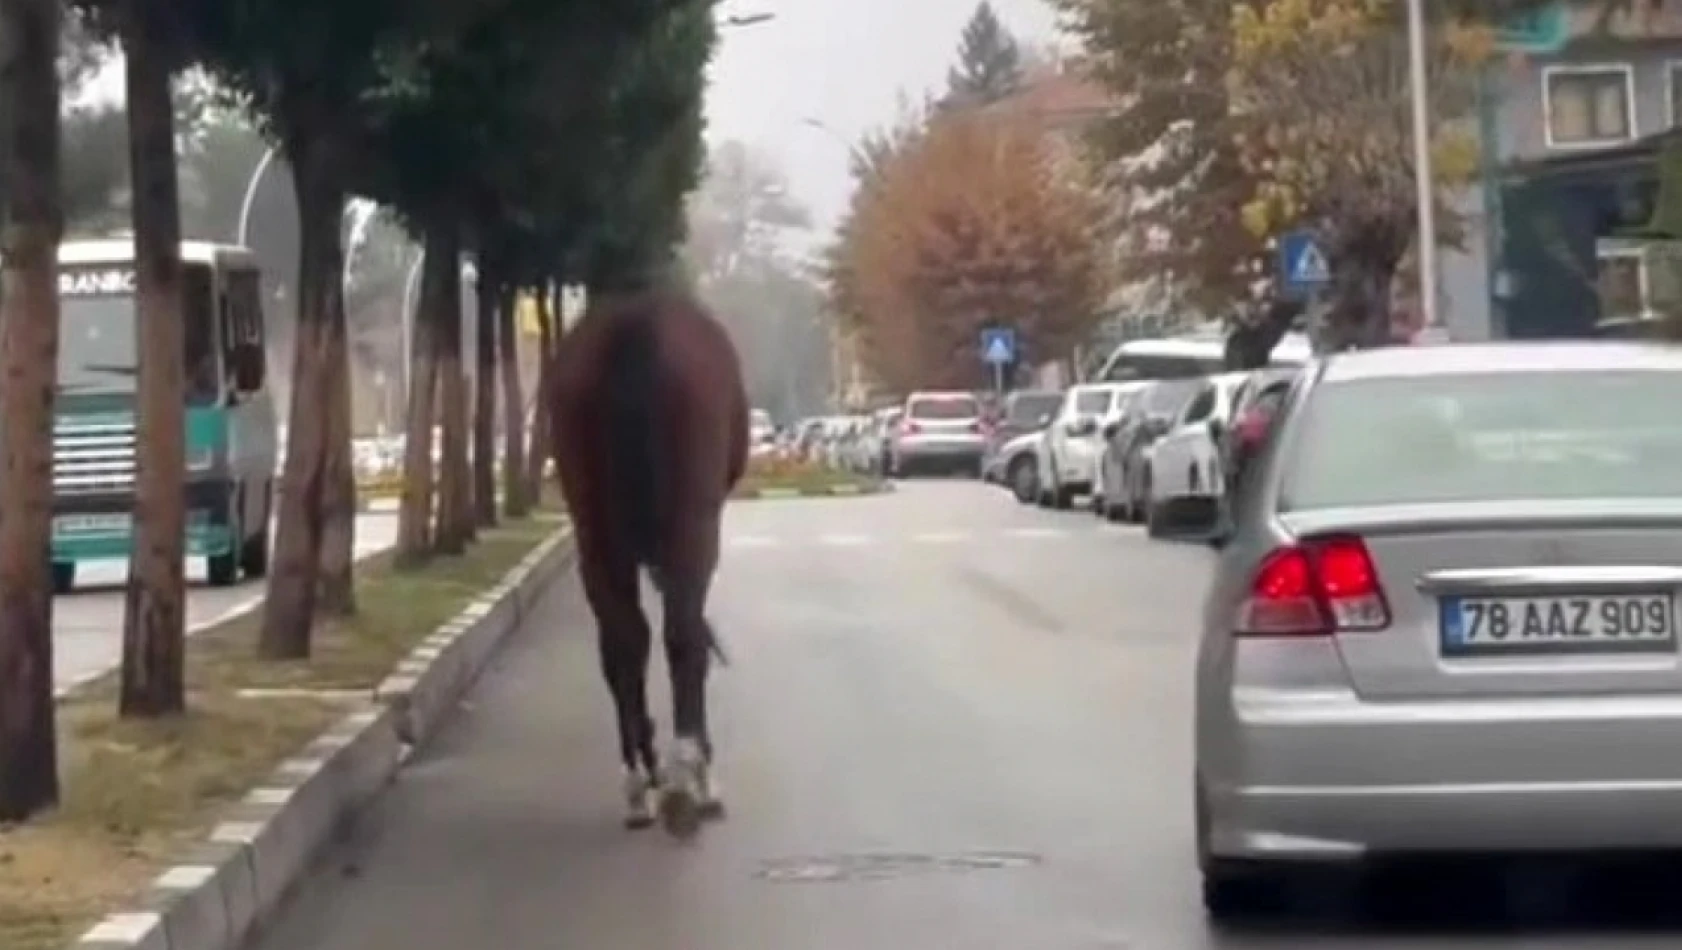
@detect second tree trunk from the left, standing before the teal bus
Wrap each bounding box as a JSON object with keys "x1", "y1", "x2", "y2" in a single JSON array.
[{"x1": 118, "y1": 0, "x2": 185, "y2": 716}]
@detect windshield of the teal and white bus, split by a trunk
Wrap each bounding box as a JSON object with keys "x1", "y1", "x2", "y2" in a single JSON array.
[{"x1": 59, "y1": 266, "x2": 220, "y2": 405}]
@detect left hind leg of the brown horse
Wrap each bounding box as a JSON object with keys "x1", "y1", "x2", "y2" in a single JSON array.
[{"x1": 579, "y1": 541, "x2": 658, "y2": 829}]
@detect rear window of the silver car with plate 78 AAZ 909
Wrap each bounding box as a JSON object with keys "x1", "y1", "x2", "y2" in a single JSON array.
[{"x1": 1280, "y1": 370, "x2": 1682, "y2": 511}]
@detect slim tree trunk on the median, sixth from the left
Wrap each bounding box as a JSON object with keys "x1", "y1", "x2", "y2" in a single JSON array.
[{"x1": 427, "y1": 220, "x2": 473, "y2": 555}]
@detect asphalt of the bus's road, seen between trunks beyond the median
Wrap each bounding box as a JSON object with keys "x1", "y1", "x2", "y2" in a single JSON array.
[{"x1": 52, "y1": 515, "x2": 397, "y2": 689}]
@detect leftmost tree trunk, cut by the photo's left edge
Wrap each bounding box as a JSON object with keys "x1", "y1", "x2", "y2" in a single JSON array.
[{"x1": 0, "y1": 0, "x2": 64, "y2": 822}]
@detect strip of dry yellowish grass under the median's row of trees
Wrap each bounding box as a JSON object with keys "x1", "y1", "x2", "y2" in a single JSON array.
[{"x1": 0, "y1": 513, "x2": 562, "y2": 950}]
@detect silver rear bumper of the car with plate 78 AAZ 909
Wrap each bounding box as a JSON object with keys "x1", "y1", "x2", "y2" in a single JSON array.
[{"x1": 1199, "y1": 693, "x2": 1682, "y2": 859}]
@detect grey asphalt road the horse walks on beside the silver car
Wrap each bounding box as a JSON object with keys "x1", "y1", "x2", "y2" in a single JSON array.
[{"x1": 243, "y1": 483, "x2": 1682, "y2": 950}]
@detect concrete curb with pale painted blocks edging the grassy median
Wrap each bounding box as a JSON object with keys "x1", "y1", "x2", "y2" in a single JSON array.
[{"x1": 76, "y1": 526, "x2": 574, "y2": 950}]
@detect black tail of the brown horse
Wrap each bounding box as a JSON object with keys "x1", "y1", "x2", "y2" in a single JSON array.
[{"x1": 606, "y1": 308, "x2": 661, "y2": 567}]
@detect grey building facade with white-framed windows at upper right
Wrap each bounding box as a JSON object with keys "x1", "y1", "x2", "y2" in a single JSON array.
[{"x1": 1440, "y1": 3, "x2": 1682, "y2": 340}]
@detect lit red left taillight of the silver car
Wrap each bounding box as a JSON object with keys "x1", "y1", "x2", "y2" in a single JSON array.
[{"x1": 1233, "y1": 536, "x2": 1389, "y2": 637}]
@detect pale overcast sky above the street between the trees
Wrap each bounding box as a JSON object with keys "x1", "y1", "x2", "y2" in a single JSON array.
[{"x1": 706, "y1": 0, "x2": 1053, "y2": 240}]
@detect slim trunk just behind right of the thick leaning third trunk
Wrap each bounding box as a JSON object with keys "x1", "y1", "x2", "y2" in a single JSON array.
[{"x1": 316, "y1": 329, "x2": 357, "y2": 617}]
